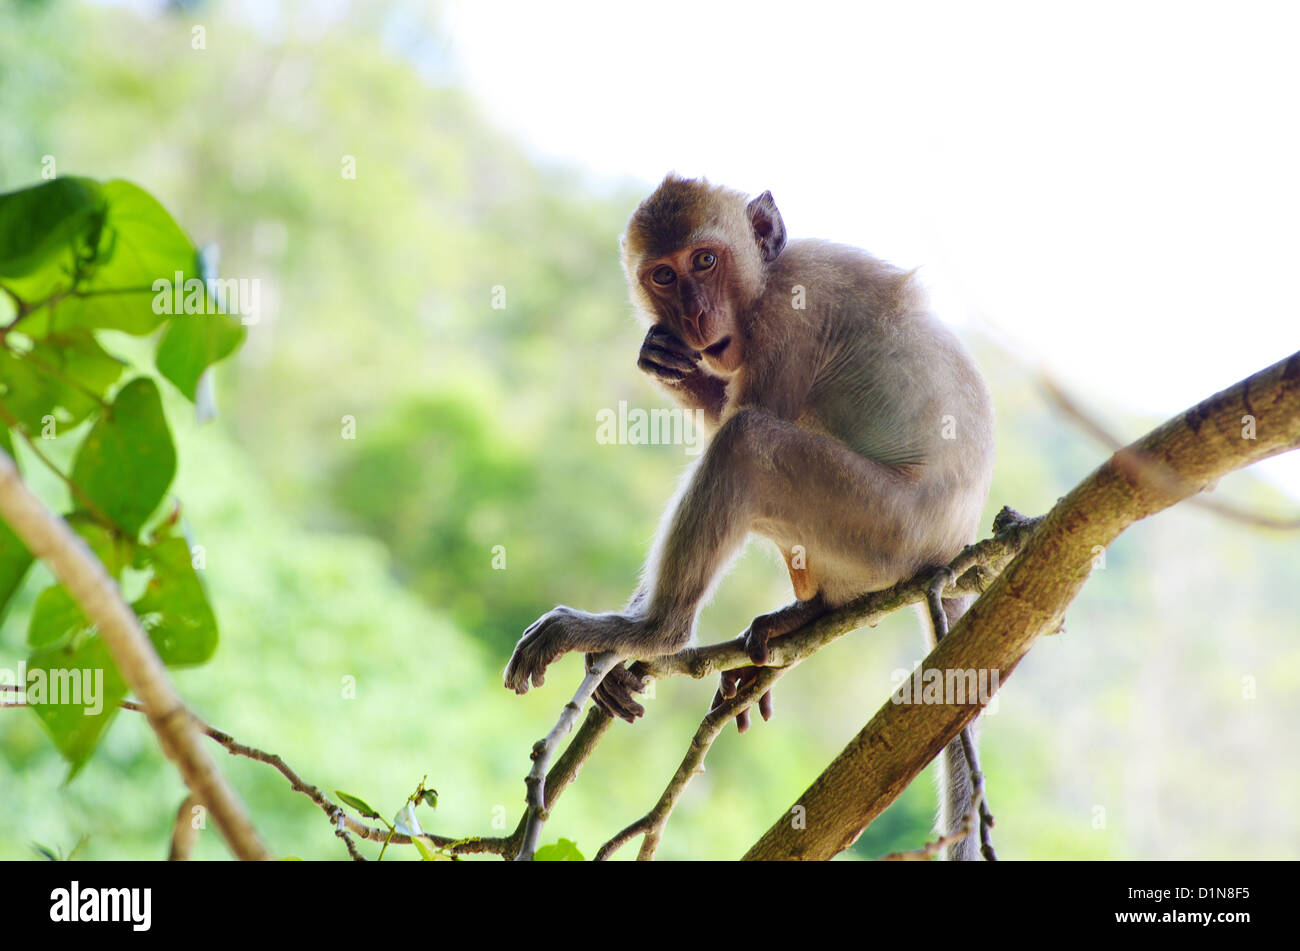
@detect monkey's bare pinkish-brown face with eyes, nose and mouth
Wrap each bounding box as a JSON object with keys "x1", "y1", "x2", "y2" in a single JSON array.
[{"x1": 640, "y1": 240, "x2": 741, "y2": 370}]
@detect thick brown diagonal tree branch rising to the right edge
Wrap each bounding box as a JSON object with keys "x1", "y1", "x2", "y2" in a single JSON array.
[{"x1": 745, "y1": 353, "x2": 1300, "y2": 859}]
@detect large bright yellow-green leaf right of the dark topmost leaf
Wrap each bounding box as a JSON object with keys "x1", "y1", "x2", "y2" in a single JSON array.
[{"x1": 52, "y1": 181, "x2": 207, "y2": 334}]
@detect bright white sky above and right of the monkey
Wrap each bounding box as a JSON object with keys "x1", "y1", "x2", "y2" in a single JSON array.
[{"x1": 447, "y1": 0, "x2": 1300, "y2": 496}]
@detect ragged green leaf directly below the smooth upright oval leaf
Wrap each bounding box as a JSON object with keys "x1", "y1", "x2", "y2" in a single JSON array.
[{"x1": 131, "y1": 538, "x2": 217, "y2": 666}]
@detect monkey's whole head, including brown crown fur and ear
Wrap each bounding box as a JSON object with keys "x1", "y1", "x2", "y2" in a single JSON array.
[{"x1": 621, "y1": 174, "x2": 785, "y2": 372}]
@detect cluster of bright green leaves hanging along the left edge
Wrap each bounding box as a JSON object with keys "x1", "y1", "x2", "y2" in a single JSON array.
[{"x1": 0, "y1": 178, "x2": 244, "y2": 774}]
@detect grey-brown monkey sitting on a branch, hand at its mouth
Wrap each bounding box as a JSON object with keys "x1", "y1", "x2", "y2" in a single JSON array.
[{"x1": 504, "y1": 174, "x2": 993, "y2": 857}]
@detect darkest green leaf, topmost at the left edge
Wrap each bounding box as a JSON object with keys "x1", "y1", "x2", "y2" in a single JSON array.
[{"x1": 0, "y1": 178, "x2": 107, "y2": 304}]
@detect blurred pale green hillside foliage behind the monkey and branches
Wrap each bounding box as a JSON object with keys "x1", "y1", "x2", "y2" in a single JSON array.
[{"x1": 0, "y1": 0, "x2": 1300, "y2": 859}]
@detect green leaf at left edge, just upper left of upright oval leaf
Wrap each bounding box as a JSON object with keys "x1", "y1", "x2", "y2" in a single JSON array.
[{"x1": 0, "y1": 329, "x2": 124, "y2": 434}]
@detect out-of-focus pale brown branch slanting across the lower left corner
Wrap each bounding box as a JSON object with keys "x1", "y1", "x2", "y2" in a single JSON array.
[{"x1": 0, "y1": 451, "x2": 270, "y2": 859}]
